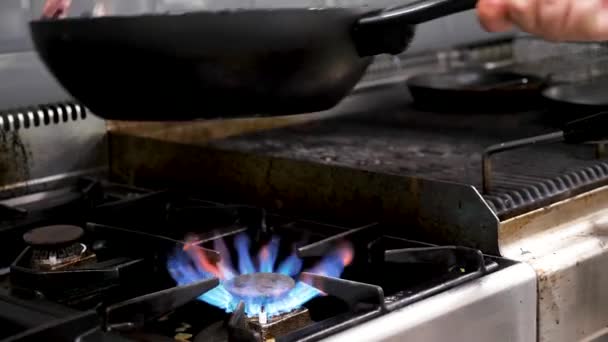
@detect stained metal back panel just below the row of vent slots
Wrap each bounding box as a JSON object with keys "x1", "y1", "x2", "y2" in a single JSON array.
[{"x1": 0, "y1": 106, "x2": 108, "y2": 189}]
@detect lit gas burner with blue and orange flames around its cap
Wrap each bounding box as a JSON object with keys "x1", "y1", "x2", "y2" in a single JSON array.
[{"x1": 167, "y1": 232, "x2": 354, "y2": 324}]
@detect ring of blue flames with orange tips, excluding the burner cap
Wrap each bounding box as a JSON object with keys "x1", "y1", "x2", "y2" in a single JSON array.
[{"x1": 167, "y1": 234, "x2": 352, "y2": 317}]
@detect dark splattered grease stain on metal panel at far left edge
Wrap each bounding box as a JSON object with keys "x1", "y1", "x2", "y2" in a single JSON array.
[{"x1": 0, "y1": 131, "x2": 31, "y2": 185}]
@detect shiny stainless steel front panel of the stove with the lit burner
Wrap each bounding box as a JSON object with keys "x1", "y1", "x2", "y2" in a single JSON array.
[{"x1": 323, "y1": 263, "x2": 537, "y2": 342}]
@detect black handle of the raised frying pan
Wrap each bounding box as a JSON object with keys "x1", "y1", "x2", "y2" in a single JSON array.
[{"x1": 354, "y1": 0, "x2": 477, "y2": 57}]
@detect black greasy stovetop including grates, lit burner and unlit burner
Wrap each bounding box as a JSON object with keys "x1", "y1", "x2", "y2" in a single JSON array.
[{"x1": 0, "y1": 179, "x2": 510, "y2": 341}]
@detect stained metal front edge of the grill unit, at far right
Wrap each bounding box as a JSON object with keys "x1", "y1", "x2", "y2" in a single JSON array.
[{"x1": 499, "y1": 186, "x2": 608, "y2": 342}]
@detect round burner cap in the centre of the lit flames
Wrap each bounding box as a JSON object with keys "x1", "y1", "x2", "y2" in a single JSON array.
[{"x1": 224, "y1": 273, "x2": 296, "y2": 299}]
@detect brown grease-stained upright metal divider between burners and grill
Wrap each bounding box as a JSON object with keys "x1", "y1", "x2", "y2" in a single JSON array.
[{"x1": 110, "y1": 133, "x2": 499, "y2": 255}]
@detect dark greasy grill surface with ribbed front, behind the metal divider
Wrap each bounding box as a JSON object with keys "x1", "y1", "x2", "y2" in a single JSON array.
[{"x1": 212, "y1": 85, "x2": 608, "y2": 219}]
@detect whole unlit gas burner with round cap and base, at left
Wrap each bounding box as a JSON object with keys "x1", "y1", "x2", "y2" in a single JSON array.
[{"x1": 23, "y1": 225, "x2": 95, "y2": 271}]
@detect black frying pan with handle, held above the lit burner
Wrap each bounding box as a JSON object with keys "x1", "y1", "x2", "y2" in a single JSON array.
[{"x1": 30, "y1": 0, "x2": 476, "y2": 121}]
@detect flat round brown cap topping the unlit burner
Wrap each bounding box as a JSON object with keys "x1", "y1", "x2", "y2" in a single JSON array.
[{"x1": 23, "y1": 225, "x2": 84, "y2": 248}]
